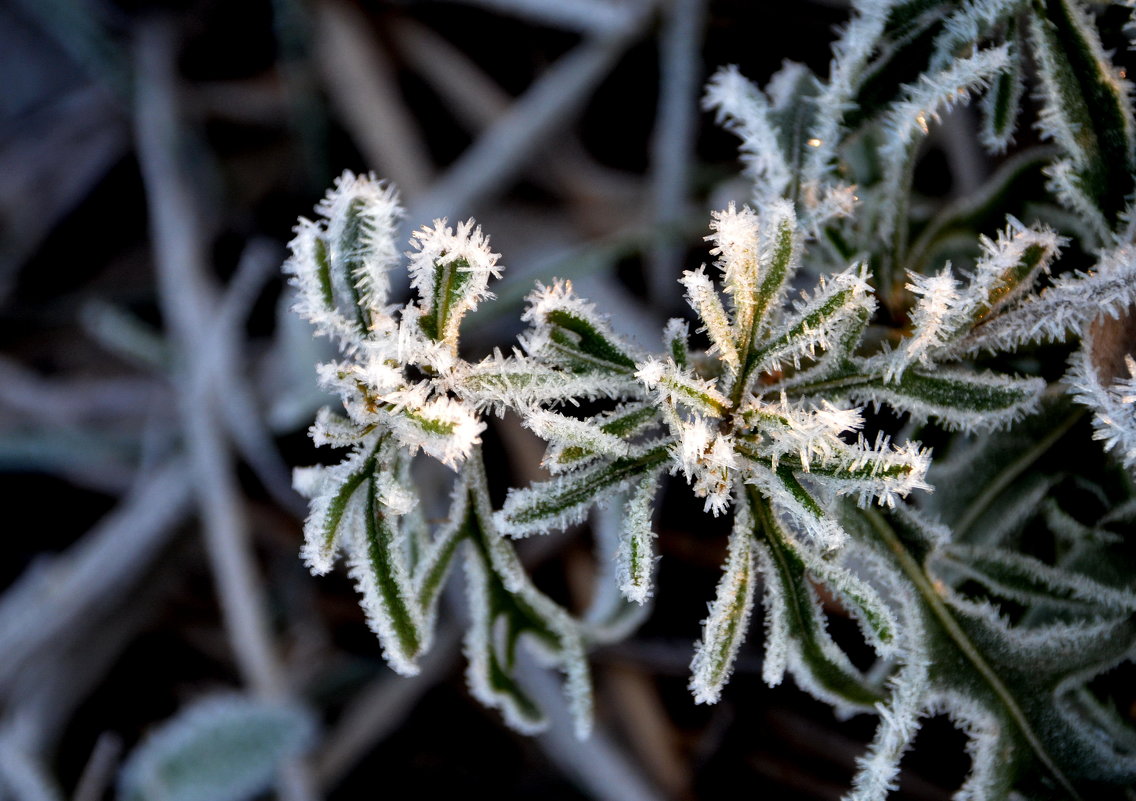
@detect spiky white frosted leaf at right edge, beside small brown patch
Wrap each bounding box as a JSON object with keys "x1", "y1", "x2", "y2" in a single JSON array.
[{"x1": 1064, "y1": 327, "x2": 1136, "y2": 470}]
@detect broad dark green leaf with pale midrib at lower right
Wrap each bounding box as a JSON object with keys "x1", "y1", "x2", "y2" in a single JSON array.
[{"x1": 867, "y1": 508, "x2": 1136, "y2": 798}]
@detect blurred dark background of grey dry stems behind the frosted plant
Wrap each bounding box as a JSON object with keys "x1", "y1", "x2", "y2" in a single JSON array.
[{"x1": 0, "y1": 0, "x2": 1013, "y2": 801}]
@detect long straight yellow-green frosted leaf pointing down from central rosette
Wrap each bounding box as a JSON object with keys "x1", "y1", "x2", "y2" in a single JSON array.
[{"x1": 690, "y1": 501, "x2": 757, "y2": 703}]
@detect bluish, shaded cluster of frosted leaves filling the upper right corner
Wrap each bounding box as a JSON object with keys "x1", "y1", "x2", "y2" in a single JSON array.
[{"x1": 704, "y1": 0, "x2": 1136, "y2": 467}]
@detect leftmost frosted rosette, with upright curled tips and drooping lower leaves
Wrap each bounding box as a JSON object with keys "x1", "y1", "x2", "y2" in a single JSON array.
[{"x1": 285, "y1": 173, "x2": 591, "y2": 736}]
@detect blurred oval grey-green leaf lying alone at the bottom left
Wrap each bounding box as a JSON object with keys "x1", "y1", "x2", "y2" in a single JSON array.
[{"x1": 118, "y1": 695, "x2": 315, "y2": 801}]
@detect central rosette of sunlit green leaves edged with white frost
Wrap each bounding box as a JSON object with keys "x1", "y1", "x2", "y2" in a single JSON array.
[{"x1": 483, "y1": 188, "x2": 1117, "y2": 710}]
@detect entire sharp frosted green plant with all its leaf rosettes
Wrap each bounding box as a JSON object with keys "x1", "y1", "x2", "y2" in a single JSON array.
[{"x1": 289, "y1": 0, "x2": 1136, "y2": 801}]
